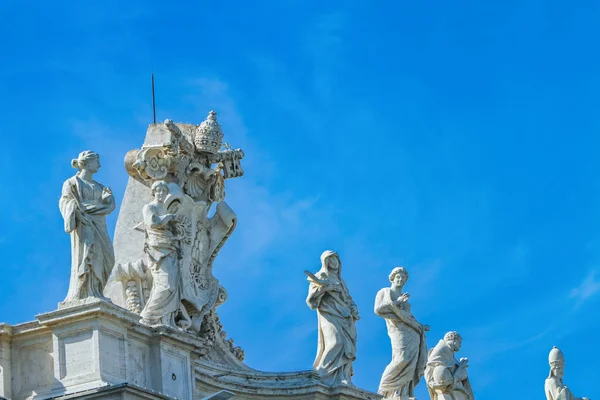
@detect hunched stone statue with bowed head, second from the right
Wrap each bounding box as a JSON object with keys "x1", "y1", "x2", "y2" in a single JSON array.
[{"x1": 425, "y1": 332, "x2": 475, "y2": 400}]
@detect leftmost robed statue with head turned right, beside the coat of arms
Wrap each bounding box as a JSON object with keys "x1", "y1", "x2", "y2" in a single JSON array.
[{"x1": 59, "y1": 150, "x2": 115, "y2": 303}]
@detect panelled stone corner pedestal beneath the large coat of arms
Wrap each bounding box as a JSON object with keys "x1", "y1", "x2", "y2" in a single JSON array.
[{"x1": 0, "y1": 300, "x2": 202, "y2": 400}]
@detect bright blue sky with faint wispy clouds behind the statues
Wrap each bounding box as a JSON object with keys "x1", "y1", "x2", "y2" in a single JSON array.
[{"x1": 0, "y1": 0, "x2": 600, "y2": 400}]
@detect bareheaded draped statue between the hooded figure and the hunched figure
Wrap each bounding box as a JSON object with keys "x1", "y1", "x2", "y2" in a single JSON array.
[{"x1": 375, "y1": 267, "x2": 429, "y2": 400}]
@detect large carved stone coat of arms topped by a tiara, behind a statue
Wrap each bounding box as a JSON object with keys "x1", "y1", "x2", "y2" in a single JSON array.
[{"x1": 111, "y1": 111, "x2": 244, "y2": 338}]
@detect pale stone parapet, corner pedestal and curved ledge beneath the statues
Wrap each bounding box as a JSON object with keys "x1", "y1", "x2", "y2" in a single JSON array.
[{"x1": 0, "y1": 299, "x2": 380, "y2": 400}]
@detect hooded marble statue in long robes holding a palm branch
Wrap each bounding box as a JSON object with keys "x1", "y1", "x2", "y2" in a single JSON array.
[{"x1": 305, "y1": 250, "x2": 359, "y2": 386}]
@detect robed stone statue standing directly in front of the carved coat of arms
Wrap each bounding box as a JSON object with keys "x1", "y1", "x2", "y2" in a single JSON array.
[{"x1": 140, "y1": 181, "x2": 191, "y2": 328}]
